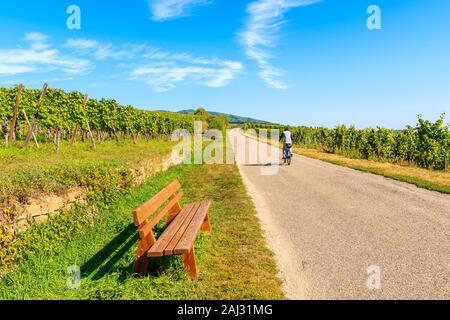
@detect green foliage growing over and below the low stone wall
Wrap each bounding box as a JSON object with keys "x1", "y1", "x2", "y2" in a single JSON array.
[{"x1": 0, "y1": 161, "x2": 132, "y2": 267}]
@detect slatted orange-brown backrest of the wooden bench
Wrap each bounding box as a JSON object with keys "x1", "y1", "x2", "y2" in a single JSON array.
[{"x1": 133, "y1": 180, "x2": 183, "y2": 238}]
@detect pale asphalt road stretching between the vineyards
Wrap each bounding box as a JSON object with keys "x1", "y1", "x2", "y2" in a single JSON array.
[{"x1": 229, "y1": 130, "x2": 450, "y2": 299}]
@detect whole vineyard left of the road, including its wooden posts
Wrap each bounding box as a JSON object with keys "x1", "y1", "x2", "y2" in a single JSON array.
[{"x1": 0, "y1": 85, "x2": 195, "y2": 147}]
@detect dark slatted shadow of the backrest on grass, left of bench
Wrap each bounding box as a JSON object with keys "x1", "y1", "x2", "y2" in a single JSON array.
[{"x1": 81, "y1": 224, "x2": 139, "y2": 281}]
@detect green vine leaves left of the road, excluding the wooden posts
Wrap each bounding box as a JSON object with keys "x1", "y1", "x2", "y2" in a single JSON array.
[{"x1": 0, "y1": 87, "x2": 195, "y2": 142}]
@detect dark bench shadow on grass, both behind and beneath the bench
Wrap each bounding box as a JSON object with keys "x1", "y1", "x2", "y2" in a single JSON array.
[{"x1": 81, "y1": 224, "x2": 176, "y2": 282}]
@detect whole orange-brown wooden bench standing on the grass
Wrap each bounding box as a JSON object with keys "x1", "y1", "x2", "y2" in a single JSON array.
[{"x1": 133, "y1": 180, "x2": 211, "y2": 279}]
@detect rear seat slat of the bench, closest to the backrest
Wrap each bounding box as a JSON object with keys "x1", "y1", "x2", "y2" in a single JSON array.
[{"x1": 148, "y1": 203, "x2": 199, "y2": 258}]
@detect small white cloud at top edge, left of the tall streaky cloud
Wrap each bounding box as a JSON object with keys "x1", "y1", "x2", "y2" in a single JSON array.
[{"x1": 148, "y1": 0, "x2": 211, "y2": 21}]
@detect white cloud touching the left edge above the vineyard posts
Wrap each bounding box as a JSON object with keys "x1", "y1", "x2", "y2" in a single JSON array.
[{"x1": 0, "y1": 32, "x2": 90, "y2": 75}]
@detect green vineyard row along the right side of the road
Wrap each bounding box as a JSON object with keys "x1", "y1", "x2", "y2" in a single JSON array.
[{"x1": 244, "y1": 115, "x2": 450, "y2": 171}]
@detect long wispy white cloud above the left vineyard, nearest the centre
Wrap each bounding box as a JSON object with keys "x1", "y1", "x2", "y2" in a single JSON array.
[{"x1": 65, "y1": 39, "x2": 243, "y2": 92}]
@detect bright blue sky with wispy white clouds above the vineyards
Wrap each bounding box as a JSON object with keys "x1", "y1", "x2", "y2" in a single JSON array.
[{"x1": 0, "y1": 0, "x2": 450, "y2": 128}]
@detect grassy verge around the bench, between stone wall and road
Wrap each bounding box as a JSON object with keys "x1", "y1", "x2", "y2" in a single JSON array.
[{"x1": 0, "y1": 165, "x2": 284, "y2": 299}]
